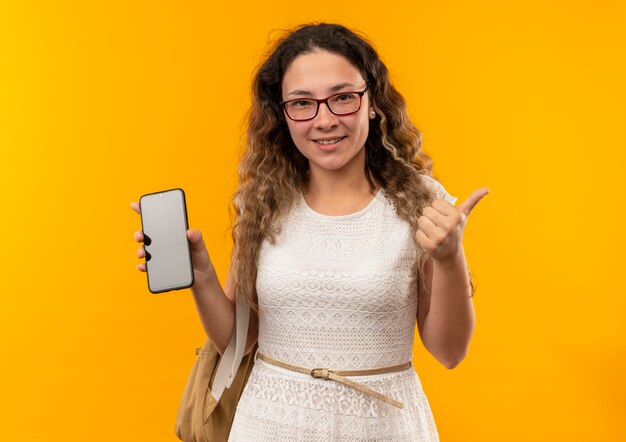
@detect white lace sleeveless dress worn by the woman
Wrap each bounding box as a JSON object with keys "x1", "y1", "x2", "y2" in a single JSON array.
[{"x1": 229, "y1": 177, "x2": 456, "y2": 442}]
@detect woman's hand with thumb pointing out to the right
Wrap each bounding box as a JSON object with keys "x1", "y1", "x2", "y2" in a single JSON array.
[{"x1": 415, "y1": 187, "x2": 491, "y2": 262}]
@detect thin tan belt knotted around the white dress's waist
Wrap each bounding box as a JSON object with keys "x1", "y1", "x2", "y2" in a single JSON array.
[{"x1": 256, "y1": 351, "x2": 411, "y2": 408}]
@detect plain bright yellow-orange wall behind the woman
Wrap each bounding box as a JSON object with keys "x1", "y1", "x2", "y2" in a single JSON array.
[{"x1": 0, "y1": 0, "x2": 626, "y2": 441}]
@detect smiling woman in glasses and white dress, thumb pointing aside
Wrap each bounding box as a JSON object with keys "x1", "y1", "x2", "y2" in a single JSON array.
[{"x1": 131, "y1": 24, "x2": 489, "y2": 442}]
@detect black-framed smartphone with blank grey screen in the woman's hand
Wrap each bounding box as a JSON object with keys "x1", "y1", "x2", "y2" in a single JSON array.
[{"x1": 139, "y1": 188, "x2": 193, "y2": 293}]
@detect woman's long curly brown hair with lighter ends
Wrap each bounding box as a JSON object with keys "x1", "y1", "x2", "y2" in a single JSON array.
[{"x1": 231, "y1": 23, "x2": 466, "y2": 310}]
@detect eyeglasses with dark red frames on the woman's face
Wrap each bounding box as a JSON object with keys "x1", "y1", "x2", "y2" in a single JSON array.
[{"x1": 280, "y1": 87, "x2": 367, "y2": 121}]
